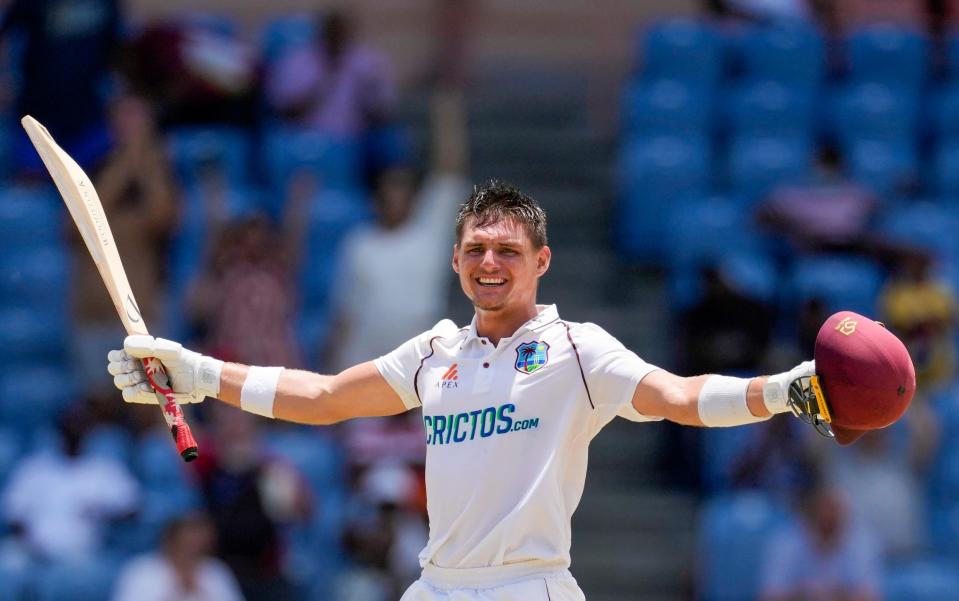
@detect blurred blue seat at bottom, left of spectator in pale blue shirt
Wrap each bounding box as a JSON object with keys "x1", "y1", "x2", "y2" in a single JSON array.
[{"x1": 698, "y1": 490, "x2": 784, "y2": 601}]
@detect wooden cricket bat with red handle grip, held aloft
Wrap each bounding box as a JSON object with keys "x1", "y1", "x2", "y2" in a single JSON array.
[{"x1": 20, "y1": 115, "x2": 198, "y2": 461}]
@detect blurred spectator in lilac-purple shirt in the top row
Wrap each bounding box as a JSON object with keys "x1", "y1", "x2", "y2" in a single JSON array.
[{"x1": 266, "y1": 11, "x2": 396, "y2": 136}]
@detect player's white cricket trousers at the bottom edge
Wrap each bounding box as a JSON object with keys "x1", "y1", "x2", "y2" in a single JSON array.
[{"x1": 400, "y1": 564, "x2": 586, "y2": 601}]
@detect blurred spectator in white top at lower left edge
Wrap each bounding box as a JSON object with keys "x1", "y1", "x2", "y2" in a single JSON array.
[{"x1": 2, "y1": 405, "x2": 140, "y2": 561}]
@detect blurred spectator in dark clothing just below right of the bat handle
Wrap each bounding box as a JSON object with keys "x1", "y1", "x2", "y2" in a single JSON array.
[{"x1": 196, "y1": 406, "x2": 312, "y2": 601}]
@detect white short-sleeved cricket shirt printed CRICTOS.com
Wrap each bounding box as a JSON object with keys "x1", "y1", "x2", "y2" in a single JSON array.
[{"x1": 375, "y1": 305, "x2": 657, "y2": 568}]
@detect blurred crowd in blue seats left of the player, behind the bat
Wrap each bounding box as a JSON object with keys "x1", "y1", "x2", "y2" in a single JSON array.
[{"x1": 0, "y1": 0, "x2": 468, "y2": 601}]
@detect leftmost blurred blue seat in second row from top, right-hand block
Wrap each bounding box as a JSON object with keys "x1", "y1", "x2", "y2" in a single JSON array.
[{"x1": 623, "y1": 79, "x2": 713, "y2": 136}]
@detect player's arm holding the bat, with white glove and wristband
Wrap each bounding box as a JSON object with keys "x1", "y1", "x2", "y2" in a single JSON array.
[{"x1": 107, "y1": 336, "x2": 407, "y2": 424}]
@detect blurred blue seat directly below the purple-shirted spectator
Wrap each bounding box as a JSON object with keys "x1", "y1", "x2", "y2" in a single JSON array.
[{"x1": 260, "y1": 127, "x2": 363, "y2": 196}]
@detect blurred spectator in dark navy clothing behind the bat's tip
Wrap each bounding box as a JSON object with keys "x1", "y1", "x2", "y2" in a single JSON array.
[{"x1": 0, "y1": 0, "x2": 122, "y2": 178}]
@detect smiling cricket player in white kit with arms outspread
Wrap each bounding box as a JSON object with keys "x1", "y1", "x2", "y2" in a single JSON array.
[{"x1": 108, "y1": 182, "x2": 815, "y2": 601}]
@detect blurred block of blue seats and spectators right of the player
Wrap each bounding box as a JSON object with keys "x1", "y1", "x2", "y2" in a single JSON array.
[{"x1": 617, "y1": 0, "x2": 959, "y2": 601}]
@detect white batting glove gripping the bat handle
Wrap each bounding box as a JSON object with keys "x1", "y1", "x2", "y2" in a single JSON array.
[{"x1": 107, "y1": 335, "x2": 223, "y2": 404}]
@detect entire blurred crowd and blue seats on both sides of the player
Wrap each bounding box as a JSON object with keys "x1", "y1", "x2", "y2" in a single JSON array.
[{"x1": 0, "y1": 0, "x2": 959, "y2": 601}]
